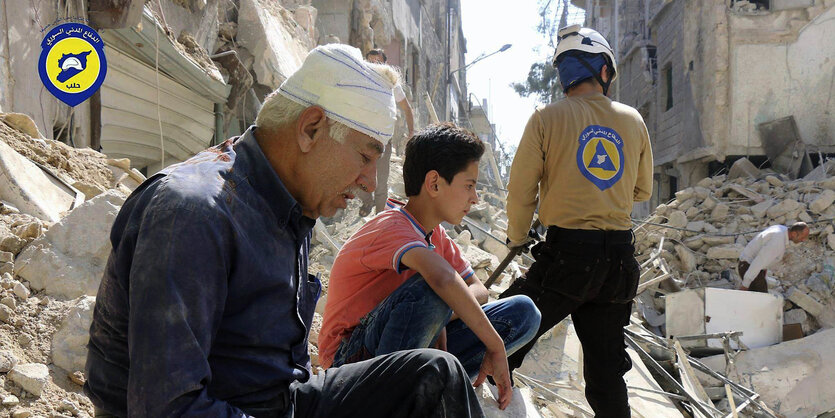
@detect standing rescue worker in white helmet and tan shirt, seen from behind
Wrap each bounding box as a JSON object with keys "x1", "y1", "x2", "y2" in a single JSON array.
[{"x1": 501, "y1": 25, "x2": 653, "y2": 417}]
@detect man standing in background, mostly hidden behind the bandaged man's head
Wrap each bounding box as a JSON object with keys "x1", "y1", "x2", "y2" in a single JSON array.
[{"x1": 358, "y1": 49, "x2": 415, "y2": 216}]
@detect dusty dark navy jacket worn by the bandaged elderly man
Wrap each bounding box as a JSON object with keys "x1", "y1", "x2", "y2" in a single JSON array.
[{"x1": 84, "y1": 129, "x2": 320, "y2": 417}]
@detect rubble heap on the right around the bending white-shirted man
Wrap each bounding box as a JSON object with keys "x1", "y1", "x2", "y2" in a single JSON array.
[{"x1": 635, "y1": 159, "x2": 835, "y2": 334}]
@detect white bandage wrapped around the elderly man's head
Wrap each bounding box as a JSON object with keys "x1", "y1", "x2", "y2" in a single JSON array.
[{"x1": 278, "y1": 44, "x2": 397, "y2": 145}]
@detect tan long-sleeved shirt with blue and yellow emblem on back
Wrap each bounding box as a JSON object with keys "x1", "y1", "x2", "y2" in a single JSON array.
[{"x1": 507, "y1": 93, "x2": 653, "y2": 243}]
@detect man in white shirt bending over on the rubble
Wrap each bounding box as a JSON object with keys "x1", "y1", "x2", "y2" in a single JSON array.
[{"x1": 737, "y1": 222, "x2": 809, "y2": 293}]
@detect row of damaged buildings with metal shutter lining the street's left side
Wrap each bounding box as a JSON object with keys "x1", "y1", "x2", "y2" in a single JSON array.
[{"x1": 0, "y1": 0, "x2": 468, "y2": 175}]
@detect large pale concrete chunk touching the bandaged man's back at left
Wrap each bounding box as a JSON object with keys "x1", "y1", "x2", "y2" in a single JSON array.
[{"x1": 15, "y1": 190, "x2": 125, "y2": 299}]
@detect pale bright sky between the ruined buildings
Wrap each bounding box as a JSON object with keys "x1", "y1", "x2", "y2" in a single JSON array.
[{"x1": 461, "y1": 0, "x2": 584, "y2": 150}]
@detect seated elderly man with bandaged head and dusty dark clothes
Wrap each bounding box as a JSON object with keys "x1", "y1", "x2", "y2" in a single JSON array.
[{"x1": 84, "y1": 44, "x2": 481, "y2": 417}]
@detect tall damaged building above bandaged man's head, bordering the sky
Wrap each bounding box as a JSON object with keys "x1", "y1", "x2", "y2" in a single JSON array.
[{"x1": 312, "y1": 0, "x2": 468, "y2": 132}]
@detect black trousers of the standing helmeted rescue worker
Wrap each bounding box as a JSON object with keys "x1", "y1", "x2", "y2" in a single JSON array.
[{"x1": 500, "y1": 226, "x2": 640, "y2": 417}]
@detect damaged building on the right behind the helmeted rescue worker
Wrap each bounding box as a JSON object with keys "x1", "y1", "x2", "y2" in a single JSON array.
[{"x1": 572, "y1": 0, "x2": 835, "y2": 215}]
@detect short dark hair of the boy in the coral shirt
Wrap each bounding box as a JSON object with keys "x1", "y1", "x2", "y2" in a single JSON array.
[{"x1": 403, "y1": 122, "x2": 484, "y2": 196}]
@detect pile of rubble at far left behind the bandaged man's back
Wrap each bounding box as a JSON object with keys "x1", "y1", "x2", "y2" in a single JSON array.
[{"x1": 0, "y1": 114, "x2": 144, "y2": 417}]
